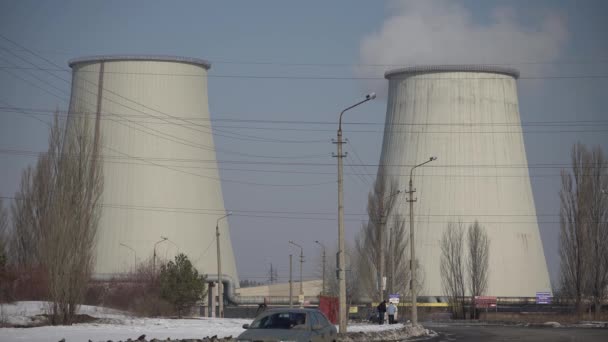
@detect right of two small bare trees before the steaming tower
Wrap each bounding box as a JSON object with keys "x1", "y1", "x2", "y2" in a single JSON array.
[{"x1": 467, "y1": 221, "x2": 490, "y2": 319}]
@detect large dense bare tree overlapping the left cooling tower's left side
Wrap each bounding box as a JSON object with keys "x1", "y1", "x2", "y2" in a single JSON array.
[{"x1": 11, "y1": 114, "x2": 103, "y2": 324}]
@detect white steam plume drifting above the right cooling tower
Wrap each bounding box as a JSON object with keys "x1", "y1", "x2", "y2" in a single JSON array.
[{"x1": 355, "y1": 0, "x2": 568, "y2": 94}]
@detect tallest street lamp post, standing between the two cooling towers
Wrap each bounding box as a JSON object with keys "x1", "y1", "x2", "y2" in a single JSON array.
[{"x1": 335, "y1": 93, "x2": 376, "y2": 334}]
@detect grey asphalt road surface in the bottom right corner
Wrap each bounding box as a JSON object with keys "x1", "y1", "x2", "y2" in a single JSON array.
[{"x1": 424, "y1": 324, "x2": 608, "y2": 342}]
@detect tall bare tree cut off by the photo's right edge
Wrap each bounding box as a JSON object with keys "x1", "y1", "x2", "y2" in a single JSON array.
[{"x1": 583, "y1": 146, "x2": 608, "y2": 319}]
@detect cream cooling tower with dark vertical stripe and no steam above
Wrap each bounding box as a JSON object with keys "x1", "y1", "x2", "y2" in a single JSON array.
[{"x1": 68, "y1": 56, "x2": 238, "y2": 284}]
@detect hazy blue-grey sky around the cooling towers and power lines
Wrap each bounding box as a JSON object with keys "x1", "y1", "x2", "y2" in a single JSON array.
[{"x1": 0, "y1": 0, "x2": 608, "y2": 286}]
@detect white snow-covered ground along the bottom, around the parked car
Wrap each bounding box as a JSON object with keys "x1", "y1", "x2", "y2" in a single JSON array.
[{"x1": 0, "y1": 302, "x2": 420, "y2": 342}]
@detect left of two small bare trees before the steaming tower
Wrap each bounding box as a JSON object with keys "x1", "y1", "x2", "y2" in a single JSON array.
[{"x1": 440, "y1": 222, "x2": 466, "y2": 318}]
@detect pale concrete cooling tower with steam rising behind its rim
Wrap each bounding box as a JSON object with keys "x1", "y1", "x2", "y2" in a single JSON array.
[{"x1": 379, "y1": 66, "x2": 551, "y2": 297}]
